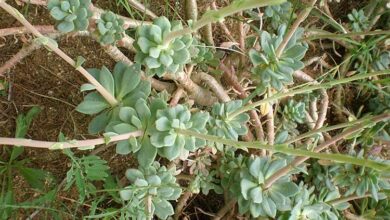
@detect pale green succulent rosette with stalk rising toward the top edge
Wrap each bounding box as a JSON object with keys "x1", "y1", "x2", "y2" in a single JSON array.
[{"x1": 134, "y1": 17, "x2": 192, "y2": 76}]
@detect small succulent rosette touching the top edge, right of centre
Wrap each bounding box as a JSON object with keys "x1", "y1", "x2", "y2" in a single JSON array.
[{"x1": 264, "y1": 2, "x2": 292, "y2": 29}]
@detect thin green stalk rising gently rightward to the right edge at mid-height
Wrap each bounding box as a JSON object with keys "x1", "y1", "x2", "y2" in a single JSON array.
[{"x1": 228, "y1": 70, "x2": 390, "y2": 118}]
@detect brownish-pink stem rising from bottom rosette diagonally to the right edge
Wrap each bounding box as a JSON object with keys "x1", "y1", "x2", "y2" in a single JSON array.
[{"x1": 264, "y1": 113, "x2": 390, "y2": 188}]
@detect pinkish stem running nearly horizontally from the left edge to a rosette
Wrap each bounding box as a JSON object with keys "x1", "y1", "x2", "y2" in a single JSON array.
[{"x1": 0, "y1": 131, "x2": 143, "y2": 149}]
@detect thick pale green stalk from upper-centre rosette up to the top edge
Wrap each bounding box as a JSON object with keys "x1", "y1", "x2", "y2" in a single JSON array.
[{"x1": 164, "y1": 0, "x2": 286, "y2": 44}]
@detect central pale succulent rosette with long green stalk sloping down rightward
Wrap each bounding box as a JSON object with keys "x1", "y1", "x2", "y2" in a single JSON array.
[{"x1": 150, "y1": 105, "x2": 209, "y2": 160}]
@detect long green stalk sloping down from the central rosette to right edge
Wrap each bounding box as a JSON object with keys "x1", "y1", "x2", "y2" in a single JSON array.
[{"x1": 176, "y1": 129, "x2": 390, "y2": 171}]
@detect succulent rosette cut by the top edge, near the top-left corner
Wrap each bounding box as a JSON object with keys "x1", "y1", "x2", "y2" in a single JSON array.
[{"x1": 47, "y1": 0, "x2": 92, "y2": 33}]
